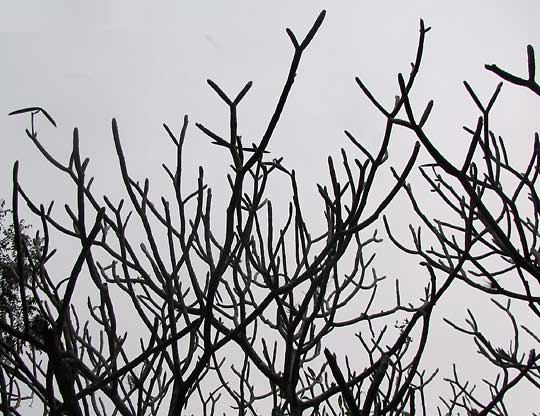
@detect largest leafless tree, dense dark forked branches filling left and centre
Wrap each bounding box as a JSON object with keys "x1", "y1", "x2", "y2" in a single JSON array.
[{"x1": 0, "y1": 11, "x2": 538, "y2": 416}]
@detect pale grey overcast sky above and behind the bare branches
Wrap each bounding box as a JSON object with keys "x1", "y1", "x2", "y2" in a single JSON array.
[{"x1": 0, "y1": 0, "x2": 540, "y2": 414}]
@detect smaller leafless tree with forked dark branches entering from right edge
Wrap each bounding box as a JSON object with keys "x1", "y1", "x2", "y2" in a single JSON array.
[{"x1": 386, "y1": 46, "x2": 540, "y2": 415}]
